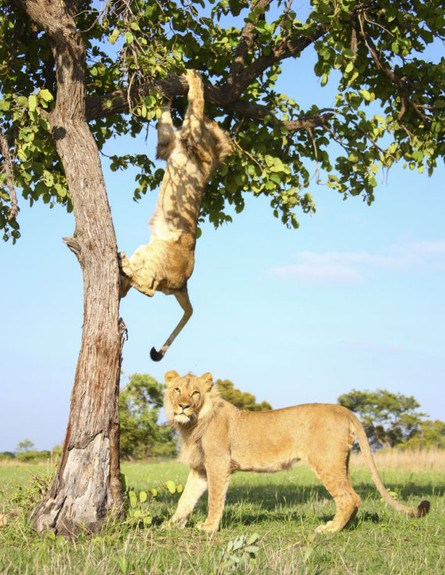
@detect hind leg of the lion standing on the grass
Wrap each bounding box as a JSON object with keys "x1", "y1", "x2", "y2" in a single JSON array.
[{"x1": 309, "y1": 451, "x2": 361, "y2": 533}]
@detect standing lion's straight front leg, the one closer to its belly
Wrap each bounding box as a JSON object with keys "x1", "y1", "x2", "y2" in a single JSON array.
[{"x1": 196, "y1": 458, "x2": 230, "y2": 533}]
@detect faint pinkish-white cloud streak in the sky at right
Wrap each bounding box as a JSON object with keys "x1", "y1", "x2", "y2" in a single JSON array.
[{"x1": 271, "y1": 240, "x2": 445, "y2": 283}]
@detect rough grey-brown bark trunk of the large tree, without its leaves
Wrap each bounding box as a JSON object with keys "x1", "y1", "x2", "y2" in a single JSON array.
[{"x1": 15, "y1": 0, "x2": 123, "y2": 536}]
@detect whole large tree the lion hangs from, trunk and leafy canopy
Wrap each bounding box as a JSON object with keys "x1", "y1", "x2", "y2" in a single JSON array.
[{"x1": 0, "y1": 0, "x2": 445, "y2": 534}]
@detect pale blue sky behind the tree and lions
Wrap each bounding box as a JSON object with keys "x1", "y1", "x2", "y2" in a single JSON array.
[{"x1": 0, "y1": 35, "x2": 445, "y2": 451}]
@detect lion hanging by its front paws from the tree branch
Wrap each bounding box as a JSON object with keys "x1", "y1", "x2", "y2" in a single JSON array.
[{"x1": 119, "y1": 70, "x2": 233, "y2": 361}]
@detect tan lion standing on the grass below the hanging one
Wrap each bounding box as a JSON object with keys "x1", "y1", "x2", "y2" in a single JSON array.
[{"x1": 164, "y1": 371, "x2": 429, "y2": 533}]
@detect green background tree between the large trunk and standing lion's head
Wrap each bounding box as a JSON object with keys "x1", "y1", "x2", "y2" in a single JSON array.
[{"x1": 119, "y1": 373, "x2": 177, "y2": 459}]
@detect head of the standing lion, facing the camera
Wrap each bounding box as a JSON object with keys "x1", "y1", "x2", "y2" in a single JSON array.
[{"x1": 164, "y1": 371, "x2": 219, "y2": 426}]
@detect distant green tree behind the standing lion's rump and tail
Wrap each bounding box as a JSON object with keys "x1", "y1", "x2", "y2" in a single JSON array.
[{"x1": 338, "y1": 389, "x2": 425, "y2": 448}]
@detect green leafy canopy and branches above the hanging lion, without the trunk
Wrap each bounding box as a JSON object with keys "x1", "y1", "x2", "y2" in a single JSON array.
[{"x1": 0, "y1": 0, "x2": 445, "y2": 241}]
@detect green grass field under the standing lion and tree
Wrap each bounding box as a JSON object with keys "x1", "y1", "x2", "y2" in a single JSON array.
[{"x1": 0, "y1": 452, "x2": 445, "y2": 575}]
